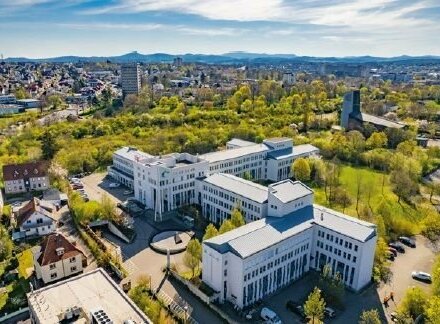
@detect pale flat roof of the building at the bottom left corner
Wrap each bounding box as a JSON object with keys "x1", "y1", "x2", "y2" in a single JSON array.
[{"x1": 27, "y1": 268, "x2": 152, "y2": 324}]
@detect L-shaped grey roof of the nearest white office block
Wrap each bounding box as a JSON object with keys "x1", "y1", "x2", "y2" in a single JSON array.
[{"x1": 203, "y1": 205, "x2": 376, "y2": 258}]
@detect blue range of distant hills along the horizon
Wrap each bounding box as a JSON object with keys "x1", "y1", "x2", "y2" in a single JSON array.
[{"x1": 5, "y1": 51, "x2": 440, "y2": 64}]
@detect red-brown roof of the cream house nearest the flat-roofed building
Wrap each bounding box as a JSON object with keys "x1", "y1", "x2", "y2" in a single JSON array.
[{"x1": 37, "y1": 233, "x2": 84, "y2": 266}]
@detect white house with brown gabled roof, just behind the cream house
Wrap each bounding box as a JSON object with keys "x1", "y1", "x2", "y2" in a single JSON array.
[{"x1": 12, "y1": 198, "x2": 56, "y2": 239}]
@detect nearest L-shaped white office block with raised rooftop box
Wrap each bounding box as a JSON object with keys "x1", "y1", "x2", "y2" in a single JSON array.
[{"x1": 202, "y1": 180, "x2": 377, "y2": 308}]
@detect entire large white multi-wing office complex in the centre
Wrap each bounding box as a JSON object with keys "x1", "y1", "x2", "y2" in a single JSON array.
[{"x1": 109, "y1": 138, "x2": 377, "y2": 307}]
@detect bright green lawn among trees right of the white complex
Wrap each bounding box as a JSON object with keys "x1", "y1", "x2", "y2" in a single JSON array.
[{"x1": 313, "y1": 165, "x2": 425, "y2": 234}]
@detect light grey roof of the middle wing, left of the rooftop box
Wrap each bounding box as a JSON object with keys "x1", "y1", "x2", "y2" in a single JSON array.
[{"x1": 203, "y1": 173, "x2": 268, "y2": 203}]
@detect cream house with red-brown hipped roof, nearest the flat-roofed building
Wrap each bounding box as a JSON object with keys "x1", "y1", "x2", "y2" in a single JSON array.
[{"x1": 33, "y1": 234, "x2": 87, "y2": 284}]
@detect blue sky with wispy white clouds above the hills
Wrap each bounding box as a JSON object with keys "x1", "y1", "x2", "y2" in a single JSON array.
[{"x1": 0, "y1": 0, "x2": 440, "y2": 58}]
